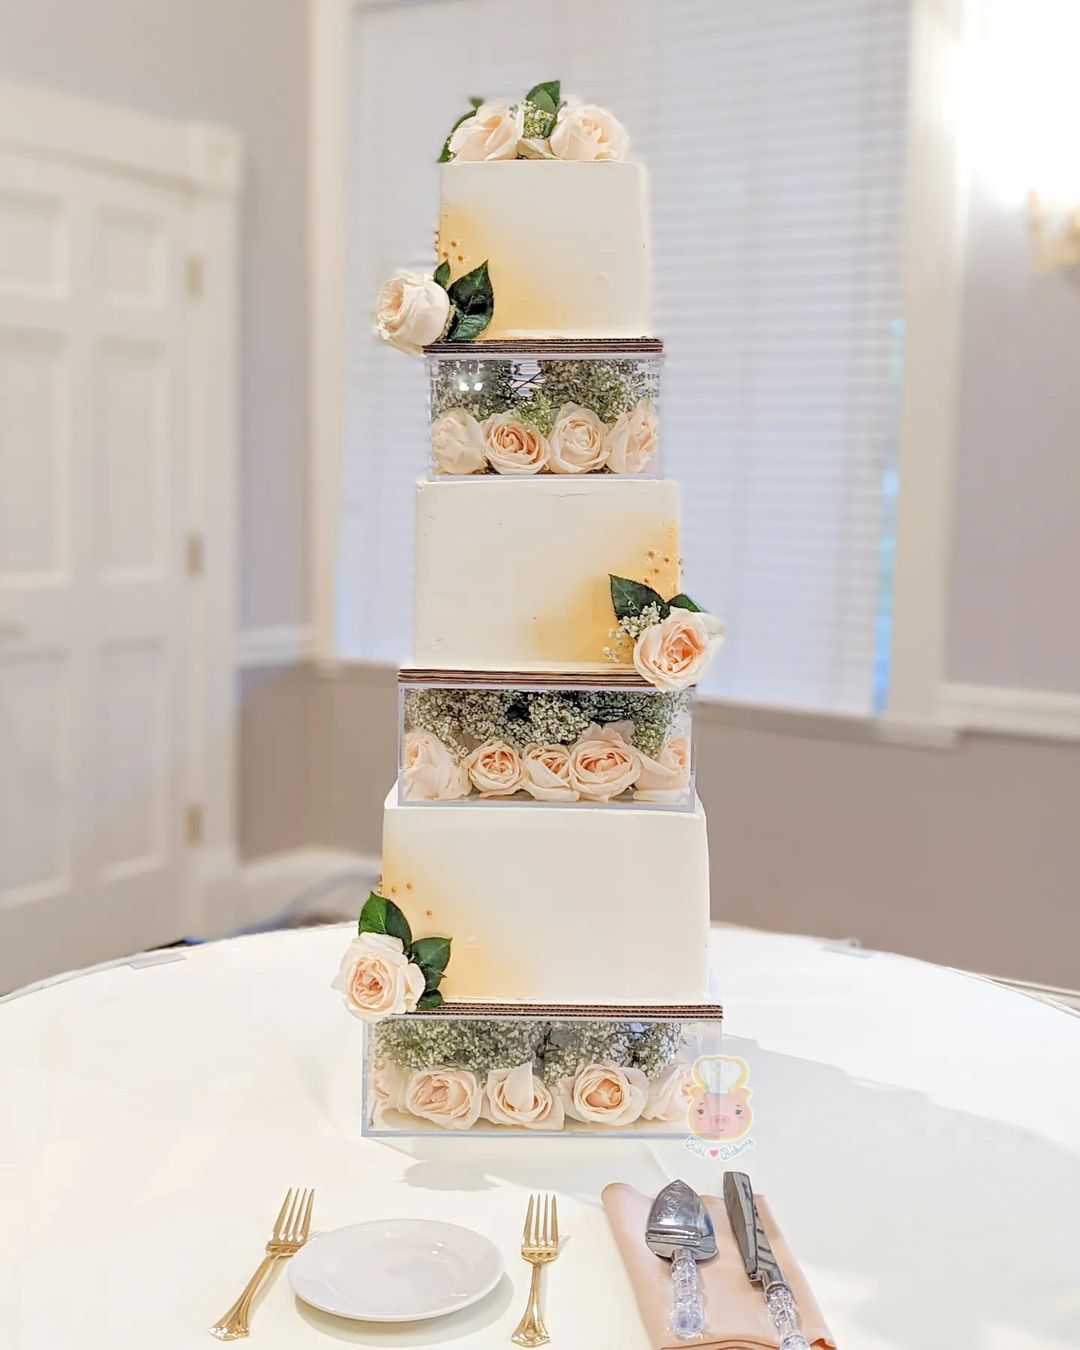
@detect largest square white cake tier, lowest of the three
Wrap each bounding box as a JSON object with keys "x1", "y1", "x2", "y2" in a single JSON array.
[{"x1": 382, "y1": 788, "x2": 709, "y2": 1007}]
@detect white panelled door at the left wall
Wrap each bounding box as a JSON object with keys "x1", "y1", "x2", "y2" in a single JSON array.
[{"x1": 0, "y1": 151, "x2": 192, "y2": 992}]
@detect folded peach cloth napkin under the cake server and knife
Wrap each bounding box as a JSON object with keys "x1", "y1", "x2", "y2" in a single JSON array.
[{"x1": 601, "y1": 1181, "x2": 836, "y2": 1350}]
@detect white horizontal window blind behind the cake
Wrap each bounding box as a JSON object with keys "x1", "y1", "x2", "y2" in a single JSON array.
[{"x1": 338, "y1": 0, "x2": 909, "y2": 713}]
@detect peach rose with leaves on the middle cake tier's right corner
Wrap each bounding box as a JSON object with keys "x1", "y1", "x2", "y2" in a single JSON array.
[{"x1": 603, "y1": 576, "x2": 724, "y2": 690}]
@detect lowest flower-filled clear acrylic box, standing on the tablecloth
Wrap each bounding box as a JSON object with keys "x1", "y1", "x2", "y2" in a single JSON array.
[{"x1": 362, "y1": 1003, "x2": 723, "y2": 1139}]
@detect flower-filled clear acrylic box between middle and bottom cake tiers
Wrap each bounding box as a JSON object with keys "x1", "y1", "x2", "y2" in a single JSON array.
[{"x1": 398, "y1": 667, "x2": 694, "y2": 810}]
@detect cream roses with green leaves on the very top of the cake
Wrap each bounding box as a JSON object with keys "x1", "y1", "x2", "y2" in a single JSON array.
[{"x1": 439, "y1": 80, "x2": 630, "y2": 163}]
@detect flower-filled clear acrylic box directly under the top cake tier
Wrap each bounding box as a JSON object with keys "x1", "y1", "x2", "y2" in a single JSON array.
[{"x1": 424, "y1": 338, "x2": 663, "y2": 478}]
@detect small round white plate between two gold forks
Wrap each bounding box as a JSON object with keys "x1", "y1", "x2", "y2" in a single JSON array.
[{"x1": 289, "y1": 1219, "x2": 502, "y2": 1322}]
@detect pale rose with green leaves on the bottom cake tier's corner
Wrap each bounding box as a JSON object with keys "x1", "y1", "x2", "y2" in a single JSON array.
[{"x1": 331, "y1": 891, "x2": 450, "y2": 1022}]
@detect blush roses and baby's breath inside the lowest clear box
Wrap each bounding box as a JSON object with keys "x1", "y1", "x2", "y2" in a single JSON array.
[{"x1": 370, "y1": 1018, "x2": 691, "y2": 1130}]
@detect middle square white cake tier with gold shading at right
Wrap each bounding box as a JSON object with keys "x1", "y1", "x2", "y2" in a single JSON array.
[{"x1": 413, "y1": 475, "x2": 680, "y2": 671}]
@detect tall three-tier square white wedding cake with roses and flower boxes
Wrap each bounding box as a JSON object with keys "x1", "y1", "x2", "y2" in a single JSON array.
[{"x1": 336, "y1": 82, "x2": 720, "y2": 1127}]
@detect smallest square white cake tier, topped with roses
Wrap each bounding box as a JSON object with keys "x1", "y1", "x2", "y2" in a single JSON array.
[{"x1": 436, "y1": 159, "x2": 652, "y2": 342}]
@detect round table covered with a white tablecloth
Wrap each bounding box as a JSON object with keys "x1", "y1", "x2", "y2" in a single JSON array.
[{"x1": 0, "y1": 927, "x2": 1080, "y2": 1350}]
